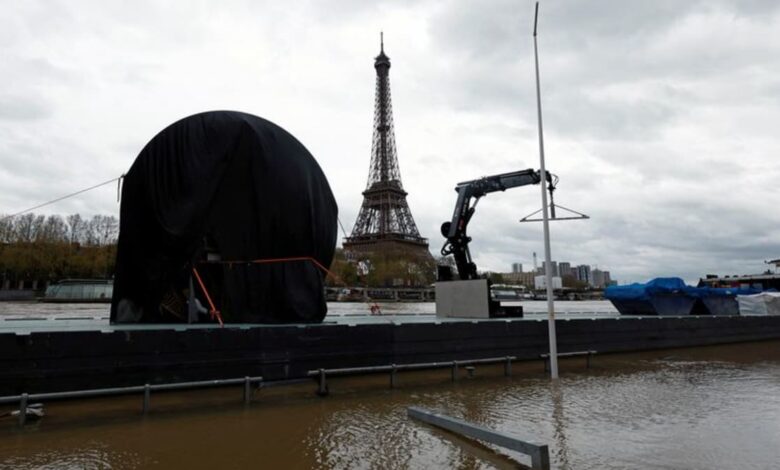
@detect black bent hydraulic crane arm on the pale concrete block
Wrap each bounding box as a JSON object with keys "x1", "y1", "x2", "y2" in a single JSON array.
[{"x1": 441, "y1": 168, "x2": 557, "y2": 280}]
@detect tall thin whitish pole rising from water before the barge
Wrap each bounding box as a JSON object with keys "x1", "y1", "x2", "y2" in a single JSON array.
[{"x1": 534, "y1": 2, "x2": 558, "y2": 379}]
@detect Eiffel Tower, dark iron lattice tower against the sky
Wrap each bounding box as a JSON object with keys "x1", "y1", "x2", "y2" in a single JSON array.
[{"x1": 344, "y1": 35, "x2": 430, "y2": 256}]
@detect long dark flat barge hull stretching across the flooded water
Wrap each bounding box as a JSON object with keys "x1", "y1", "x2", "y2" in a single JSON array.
[{"x1": 0, "y1": 314, "x2": 780, "y2": 395}]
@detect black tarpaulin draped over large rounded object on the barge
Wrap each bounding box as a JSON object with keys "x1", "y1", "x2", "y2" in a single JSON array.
[{"x1": 111, "y1": 111, "x2": 338, "y2": 323}]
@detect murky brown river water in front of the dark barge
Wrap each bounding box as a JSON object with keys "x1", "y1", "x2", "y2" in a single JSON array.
[{"x1": 0, "y1": 304, "x2": 780, "y2": 469}]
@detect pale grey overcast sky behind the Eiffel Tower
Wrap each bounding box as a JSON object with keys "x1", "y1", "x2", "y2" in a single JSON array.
[{"x1": 0, "y1": 0, "x2": 780, "y2": 283}]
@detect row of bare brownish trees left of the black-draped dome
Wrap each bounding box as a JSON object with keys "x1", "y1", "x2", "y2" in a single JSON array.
[{"x1": 0, "y1": 213, "x2": 119, "y2": 284}]
